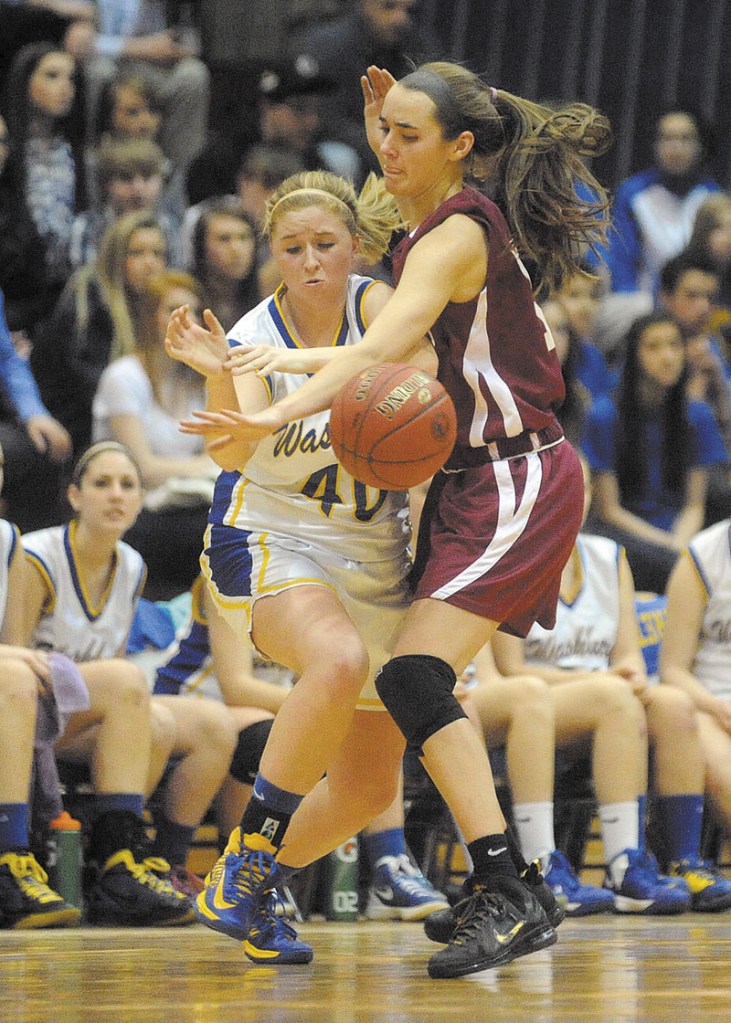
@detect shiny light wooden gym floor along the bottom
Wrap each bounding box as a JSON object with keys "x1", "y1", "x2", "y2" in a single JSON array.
[{"x1": 0, "y1": 913, "x2": 731, "y2": 1023}]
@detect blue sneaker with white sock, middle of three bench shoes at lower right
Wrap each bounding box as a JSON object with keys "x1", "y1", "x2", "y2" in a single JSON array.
[{"x1": 604, "y1": 849, "x2": 690, "y2": 916}]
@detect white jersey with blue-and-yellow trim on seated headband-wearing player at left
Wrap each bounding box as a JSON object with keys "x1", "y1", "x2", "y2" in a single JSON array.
[{"x1": 22, "y1": 522, "x2": 146, "y2": 662}]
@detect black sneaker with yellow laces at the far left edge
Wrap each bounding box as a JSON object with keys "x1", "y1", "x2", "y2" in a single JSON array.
[{"x1": 0, "y1": 849, "x2": 81, "y2": 931}]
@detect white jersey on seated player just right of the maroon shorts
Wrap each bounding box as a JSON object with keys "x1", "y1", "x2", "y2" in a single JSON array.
[{"x1": 524, "y1": 533, "x2": 624, "y2": 671}]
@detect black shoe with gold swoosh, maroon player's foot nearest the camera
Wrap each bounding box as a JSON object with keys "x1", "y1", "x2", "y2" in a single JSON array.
[{"x1": 428, "y1": 876, "x2": 557, "y2": 979}]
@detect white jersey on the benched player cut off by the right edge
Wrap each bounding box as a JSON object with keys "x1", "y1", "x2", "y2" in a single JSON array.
[{"x1": 688, "y1": 519, "x2": 731, "y2": 700}]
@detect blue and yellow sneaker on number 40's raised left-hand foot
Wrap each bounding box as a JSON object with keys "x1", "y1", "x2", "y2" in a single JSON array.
[{"x1": 193, "y1": 828, "x2": 278, "y2": 941}]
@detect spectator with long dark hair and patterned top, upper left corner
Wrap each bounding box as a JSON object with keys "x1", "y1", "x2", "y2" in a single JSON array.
[{"x1": 4, "y1": 43, "x2": 86, "y2": 293}]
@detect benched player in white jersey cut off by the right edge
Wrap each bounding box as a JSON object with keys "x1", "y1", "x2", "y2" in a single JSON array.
[{"x1": 659, "y1": 519, "x2": 731, "y2": 847}]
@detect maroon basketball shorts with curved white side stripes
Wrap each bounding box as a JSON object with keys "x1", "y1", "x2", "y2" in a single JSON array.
[{"x1": 413, "y1": 441, "x2": 584, "y2": 636}]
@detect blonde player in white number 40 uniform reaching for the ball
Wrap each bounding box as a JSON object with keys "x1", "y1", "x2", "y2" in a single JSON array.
[{"x1": 168, "y1": 172, "x2": 449, "y2": 963}]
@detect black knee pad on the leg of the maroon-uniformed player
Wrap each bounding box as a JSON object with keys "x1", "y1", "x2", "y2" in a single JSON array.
[{"x1": 375, "y1": 654, "x2": 467, "y2": 756}]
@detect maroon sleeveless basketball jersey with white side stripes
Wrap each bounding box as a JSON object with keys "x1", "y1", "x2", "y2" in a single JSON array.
[{"x1": 394, "y1": 188, "x2": 564, "y2": 448}]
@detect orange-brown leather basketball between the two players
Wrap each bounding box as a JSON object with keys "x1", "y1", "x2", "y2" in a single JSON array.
[{"x1": 330, "y1": 362, "x2": 457, "y2": 490}]
